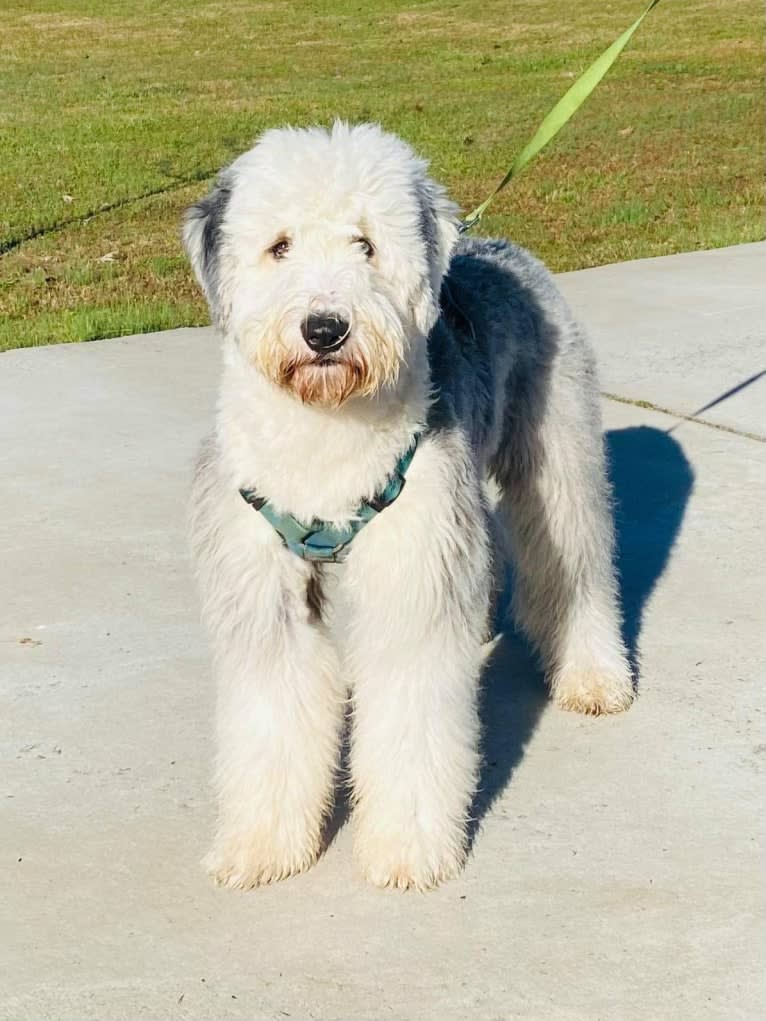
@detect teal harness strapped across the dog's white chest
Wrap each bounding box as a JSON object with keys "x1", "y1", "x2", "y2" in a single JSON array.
[{"x1": 240, "y1": 435, "x2": 420, "y2": 564}]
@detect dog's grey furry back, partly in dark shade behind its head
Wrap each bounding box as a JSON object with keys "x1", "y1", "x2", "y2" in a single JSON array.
[{"x1": 428, "y1": 238, "x2": 595, "y2": 482}]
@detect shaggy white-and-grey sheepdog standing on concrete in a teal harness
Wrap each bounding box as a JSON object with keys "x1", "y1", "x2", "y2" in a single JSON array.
[{"x1": 184, "y1": 124, "x2": 633, "y2": 889}]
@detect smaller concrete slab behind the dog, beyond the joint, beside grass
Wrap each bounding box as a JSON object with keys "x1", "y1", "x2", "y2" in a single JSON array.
[{"x1": 559, "y1": 242, "x2": 766, "y2": 436}]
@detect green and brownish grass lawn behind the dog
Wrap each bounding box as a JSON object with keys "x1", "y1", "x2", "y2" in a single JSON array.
[{"x1": 0, "y1": 0, "x2": 765, "y2": 350}]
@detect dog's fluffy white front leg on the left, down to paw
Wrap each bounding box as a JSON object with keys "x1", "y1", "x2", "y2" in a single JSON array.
[{"x1": 197, "y1": 508, "x2": 345, "y2": 888}]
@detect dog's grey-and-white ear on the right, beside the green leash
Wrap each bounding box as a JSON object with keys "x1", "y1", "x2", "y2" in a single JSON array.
[{"x1": 415, "y1": 176, "x2": 460, "y2": 334}]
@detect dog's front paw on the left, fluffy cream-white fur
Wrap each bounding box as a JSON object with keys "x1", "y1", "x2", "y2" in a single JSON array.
[{"x1": 202, "y1": 834, "x2": 319, "y2": 890}]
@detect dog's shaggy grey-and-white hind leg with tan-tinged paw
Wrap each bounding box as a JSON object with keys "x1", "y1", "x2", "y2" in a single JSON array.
[{"x1": 496, "y1": 338, "x2": 633, "y2": 715}]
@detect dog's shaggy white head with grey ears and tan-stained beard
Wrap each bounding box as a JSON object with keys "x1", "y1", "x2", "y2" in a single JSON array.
[{"x1": 184, "y1": 124, "x2": 458, "y2": 406}]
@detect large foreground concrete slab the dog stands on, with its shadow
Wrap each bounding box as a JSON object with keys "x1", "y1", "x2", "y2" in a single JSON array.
[{"x1": 0, "y1": 257, "x2": 766, "y2": 1021}]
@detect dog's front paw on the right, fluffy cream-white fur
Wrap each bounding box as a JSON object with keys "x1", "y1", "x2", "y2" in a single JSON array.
[{"x1": 354, "y1": 834, "x2": 466, "y2": 892}]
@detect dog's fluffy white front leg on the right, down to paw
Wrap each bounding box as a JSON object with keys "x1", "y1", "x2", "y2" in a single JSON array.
[{"x1": 346, "y1": 440, "x2": 490, "y2": 890}]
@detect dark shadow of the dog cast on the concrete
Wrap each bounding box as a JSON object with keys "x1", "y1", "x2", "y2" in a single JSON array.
[{"x1": 326, "y1": 426, "x2": 695, "y2": 844}]
